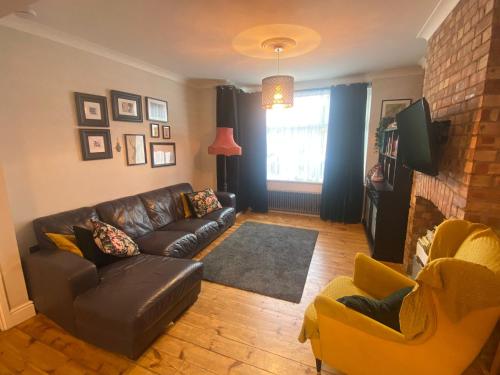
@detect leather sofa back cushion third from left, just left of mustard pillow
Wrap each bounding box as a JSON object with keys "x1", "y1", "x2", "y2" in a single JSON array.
[{"x1": 139, "y1": 187, "x2": 177, "y2": 229}]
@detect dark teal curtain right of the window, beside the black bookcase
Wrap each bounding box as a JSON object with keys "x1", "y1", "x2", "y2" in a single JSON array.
[{"x1": 320, "y1": 83, "x2": 368, "y2": 223}]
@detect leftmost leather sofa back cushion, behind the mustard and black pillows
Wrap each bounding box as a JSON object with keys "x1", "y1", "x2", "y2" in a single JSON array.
[{"x1": 33, "y1": 207, "x2": 98, "y2": 250}]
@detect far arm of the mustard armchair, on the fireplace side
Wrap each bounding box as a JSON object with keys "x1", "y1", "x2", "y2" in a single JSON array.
[{"x1": 353, "y1": 253, "x2": 416, "y2": 299}]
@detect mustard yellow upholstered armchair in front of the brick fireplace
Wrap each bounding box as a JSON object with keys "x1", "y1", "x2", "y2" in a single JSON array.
[{"x1": 299, "y1": 220, "x2": 500, "y2": 375}]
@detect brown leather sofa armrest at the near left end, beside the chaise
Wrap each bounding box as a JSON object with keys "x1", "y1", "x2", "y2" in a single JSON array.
[{"x1": 24, "y1": 249, "x2": 99, "y2": 333}]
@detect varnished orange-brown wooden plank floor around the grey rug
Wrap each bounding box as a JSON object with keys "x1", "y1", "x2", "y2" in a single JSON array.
[{"x1": 0, "y1": 213, "x2": 368, "y2": 375}]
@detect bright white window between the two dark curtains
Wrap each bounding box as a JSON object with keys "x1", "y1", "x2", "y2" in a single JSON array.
[{"x1": 267, "y1": 89, "x2": 330, "y2": 183}]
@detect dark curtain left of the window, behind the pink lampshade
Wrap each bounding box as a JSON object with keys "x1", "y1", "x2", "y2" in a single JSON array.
[{"x1": 217, "y1": 86, "x2": 268, "y2": 212}]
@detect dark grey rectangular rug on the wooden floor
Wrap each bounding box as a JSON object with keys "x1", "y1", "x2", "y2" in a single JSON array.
[{"x1": 201, "y1": 221, "x2": 318, "y2": 303}]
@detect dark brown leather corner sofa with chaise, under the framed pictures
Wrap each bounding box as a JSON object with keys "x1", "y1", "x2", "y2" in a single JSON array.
[{"x1": 24, "y1": 183, "x2": 236, "y2": 358}]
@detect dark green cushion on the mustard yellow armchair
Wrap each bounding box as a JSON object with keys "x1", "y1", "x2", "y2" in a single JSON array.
[{"x1": 337, "y1": 286, "x2": 413, "y2": 331}]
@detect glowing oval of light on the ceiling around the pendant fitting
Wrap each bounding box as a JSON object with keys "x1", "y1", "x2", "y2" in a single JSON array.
[{"x1": 232, "y1": 24, "x2": 321, "y2": 59}]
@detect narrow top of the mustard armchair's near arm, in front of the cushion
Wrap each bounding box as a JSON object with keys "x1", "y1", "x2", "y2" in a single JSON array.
[{"x1": 314, "y1": 294, "x2": 407, "y2": 343}]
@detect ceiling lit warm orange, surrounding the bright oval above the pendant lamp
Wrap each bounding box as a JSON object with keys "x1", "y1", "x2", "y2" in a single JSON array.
[{"x1": 1, "y1": 0, "x2": 439, "y2": 85}]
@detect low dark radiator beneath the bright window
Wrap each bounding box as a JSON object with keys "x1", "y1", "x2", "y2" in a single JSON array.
[{"x1": 268, "y1": 191, "x2": 321, "y2": 215}]
